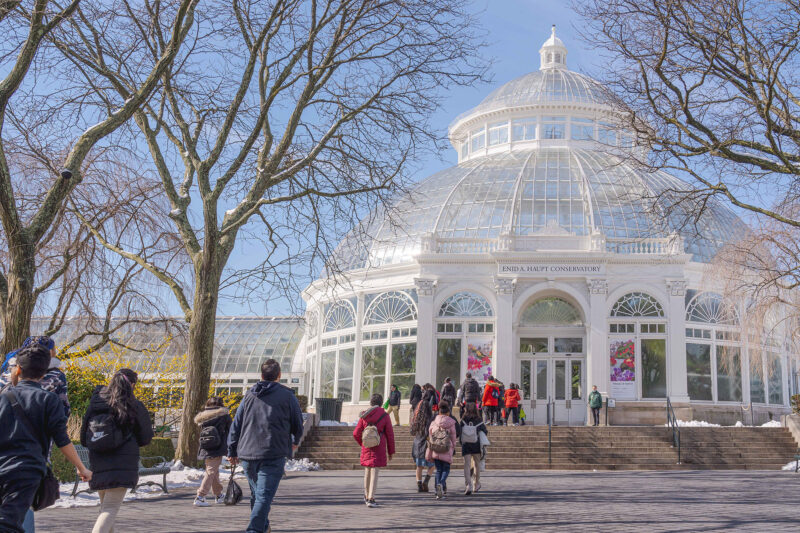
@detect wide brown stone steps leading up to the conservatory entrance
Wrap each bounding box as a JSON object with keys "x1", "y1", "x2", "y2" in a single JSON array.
[{"x1": 297, "y1": 426, "x2": 797, "y2": 470}]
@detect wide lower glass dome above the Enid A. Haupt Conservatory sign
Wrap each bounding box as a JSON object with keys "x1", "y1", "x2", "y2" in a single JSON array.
[{"x1": 335, "y1": 147, "x2": 745, "y2": 269}]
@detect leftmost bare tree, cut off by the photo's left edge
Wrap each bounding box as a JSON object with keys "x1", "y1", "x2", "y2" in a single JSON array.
[{"x1": 0, "y1": 0, "x2": 197, "y2": 352}]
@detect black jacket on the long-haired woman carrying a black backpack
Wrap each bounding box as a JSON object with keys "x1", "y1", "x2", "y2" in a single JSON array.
[{"x1": 81, "y1": 386, "x2": 153, "y2": 490}]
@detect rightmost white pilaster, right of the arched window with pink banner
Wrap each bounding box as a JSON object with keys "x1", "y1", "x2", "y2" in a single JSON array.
[{"x1": 666, "y1": 279, "x2": 689, "y2": 403}]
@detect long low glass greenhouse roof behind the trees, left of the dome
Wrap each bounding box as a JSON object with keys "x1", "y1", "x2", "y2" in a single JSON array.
[{"x1": 22, "y1": 317, "x2": 303, "y2": 379}]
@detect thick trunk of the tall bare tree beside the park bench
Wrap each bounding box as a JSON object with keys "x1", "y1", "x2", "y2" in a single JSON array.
[{"x1": 175, "y1": 253, "x2": 222, "y2": 465}]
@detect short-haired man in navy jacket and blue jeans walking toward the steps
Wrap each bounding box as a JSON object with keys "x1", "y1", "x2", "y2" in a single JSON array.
[{"x1": 228, "y1": 359, "x2": 303, "y2": 533}]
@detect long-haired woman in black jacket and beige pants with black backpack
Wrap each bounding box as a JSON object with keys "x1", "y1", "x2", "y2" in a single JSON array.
[{"x1": 81, "y1": 368, "x2": 153, "y2": 533}]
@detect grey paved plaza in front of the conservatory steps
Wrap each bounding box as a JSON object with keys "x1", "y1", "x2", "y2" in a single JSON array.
[{"x1": 36, "y1": 471, "x2": 800, "y2": 533}]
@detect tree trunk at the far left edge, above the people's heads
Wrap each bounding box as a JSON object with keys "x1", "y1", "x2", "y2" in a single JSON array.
[{"x1": 0, "y1": 243, "x2": 36, "y2": 356}]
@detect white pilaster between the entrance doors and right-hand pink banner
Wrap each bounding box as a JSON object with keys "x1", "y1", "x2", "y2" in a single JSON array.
[{"x1": 586, "y1": 279, "x2": 611, "y2": 416}]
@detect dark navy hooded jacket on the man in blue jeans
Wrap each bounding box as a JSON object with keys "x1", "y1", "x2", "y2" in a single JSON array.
[{"x1": 228, "y1": 381, "x2": 303, "y2": 461}]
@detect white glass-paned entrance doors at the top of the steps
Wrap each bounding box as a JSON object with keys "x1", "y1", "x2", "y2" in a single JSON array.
[{"x1": 520, "y1": 354, "x2": 586, "y2": 426}]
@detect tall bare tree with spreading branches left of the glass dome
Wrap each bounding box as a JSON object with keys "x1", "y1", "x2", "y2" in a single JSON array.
[{"x1": 58, "y1": 0, "x2": 483, "y2": 461}]
